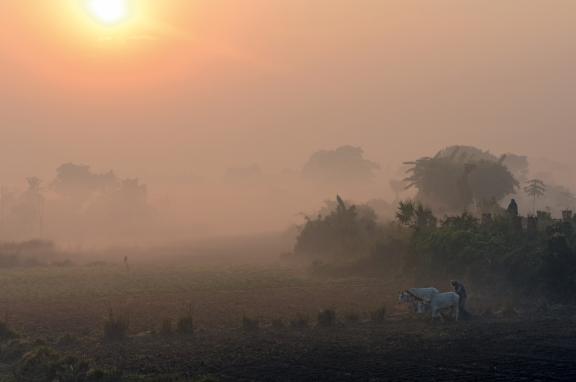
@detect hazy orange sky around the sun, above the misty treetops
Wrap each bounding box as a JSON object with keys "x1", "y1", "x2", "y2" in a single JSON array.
[{"x1": 0, "y1": 0, "x2": 576, "y2": 191}]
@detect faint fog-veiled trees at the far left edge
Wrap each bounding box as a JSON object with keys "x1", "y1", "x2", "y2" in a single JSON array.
[{"x1": 0, "y1": 163, "x2": 154, "y2": 243}]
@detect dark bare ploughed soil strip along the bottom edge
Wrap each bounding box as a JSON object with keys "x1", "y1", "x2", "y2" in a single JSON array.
[{"x1": 62, "y1": 319, "x2": 576, "y2": 381}]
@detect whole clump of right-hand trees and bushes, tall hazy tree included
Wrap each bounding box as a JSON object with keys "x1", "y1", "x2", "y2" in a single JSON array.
[{"x1": 295, "y1": 147, "x2": 576, "y2": 300}]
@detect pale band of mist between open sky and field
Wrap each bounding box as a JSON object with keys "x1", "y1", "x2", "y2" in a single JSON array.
[{"x1": 0, "y1": 145, "x2": 575, "y2": 251}]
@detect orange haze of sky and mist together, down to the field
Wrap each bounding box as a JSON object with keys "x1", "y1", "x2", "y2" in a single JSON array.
[{"x1": 0, "y1": 0, "x2": 576, "y2": 245}]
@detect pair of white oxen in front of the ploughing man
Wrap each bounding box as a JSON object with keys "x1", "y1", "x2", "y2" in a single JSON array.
[{"x1": 400, "y1": 288, "x2": 460, "y2": 321}]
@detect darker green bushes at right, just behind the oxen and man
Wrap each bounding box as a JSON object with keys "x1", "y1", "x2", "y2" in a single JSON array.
[{"x1": 398, "y1": 201, "x2": 576, "y2": 300}]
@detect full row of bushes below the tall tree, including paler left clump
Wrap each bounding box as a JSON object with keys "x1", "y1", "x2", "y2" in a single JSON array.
[{"x1": 296, "y1": 198, "x2": 576, "y2": 301}]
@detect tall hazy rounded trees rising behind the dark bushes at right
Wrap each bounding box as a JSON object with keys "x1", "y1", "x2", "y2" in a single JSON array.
[{"x1": 400, "y1": 146, "x2": 576, "y2": 215}]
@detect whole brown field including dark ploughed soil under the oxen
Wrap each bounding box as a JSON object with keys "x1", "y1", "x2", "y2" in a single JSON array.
[{"x1": 0, "y1": 269, "x2": 576, "y2": 381}]
